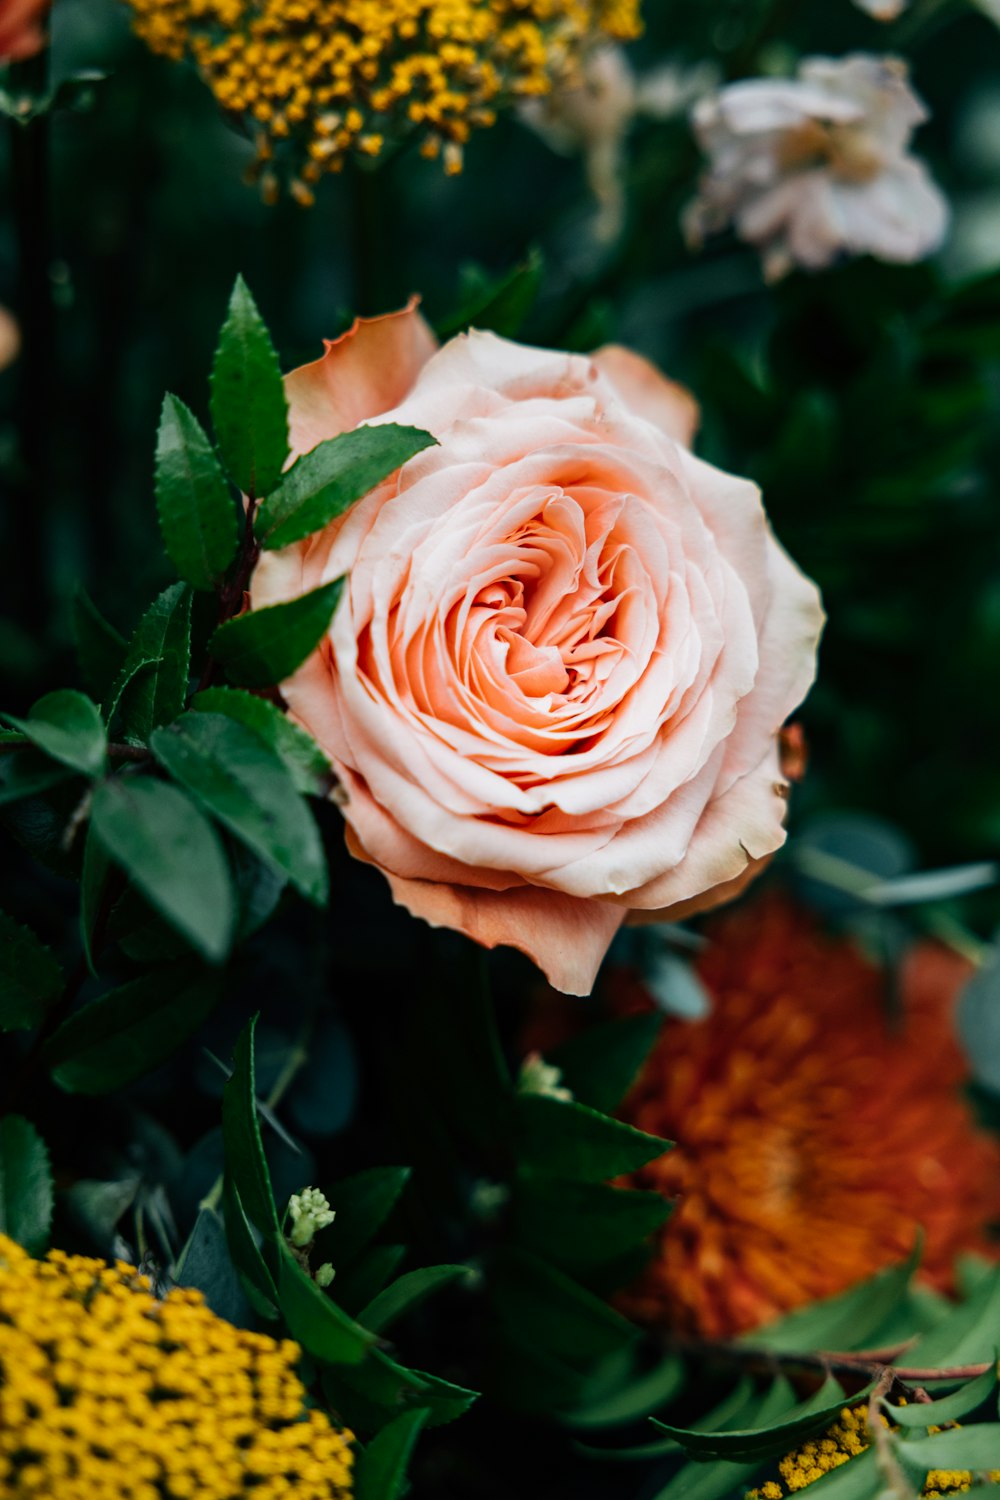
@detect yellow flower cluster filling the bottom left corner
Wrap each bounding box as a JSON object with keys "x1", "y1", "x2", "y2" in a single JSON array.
[{"x1": 0, "y1": 1236, "x2": 352, "y2": 1500}]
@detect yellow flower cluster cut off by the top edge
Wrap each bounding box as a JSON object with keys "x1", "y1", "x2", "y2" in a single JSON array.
[{"x1": 126, "y1": 0, "x2": 640, "y2": 201}]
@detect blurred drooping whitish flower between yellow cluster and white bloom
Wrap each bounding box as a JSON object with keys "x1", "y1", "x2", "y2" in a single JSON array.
[{"x1": 520, "y1": 44, "x2": 718, "y2": 243}]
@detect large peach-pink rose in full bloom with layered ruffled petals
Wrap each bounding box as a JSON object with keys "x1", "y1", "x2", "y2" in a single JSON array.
[{"x1": 253, "y1": 305, "x2": 823, "y2": 995}]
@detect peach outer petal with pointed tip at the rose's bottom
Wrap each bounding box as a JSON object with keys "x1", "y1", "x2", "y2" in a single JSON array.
[{"x1": 384, "y1": 872, "x2": 625, "y2": 995}]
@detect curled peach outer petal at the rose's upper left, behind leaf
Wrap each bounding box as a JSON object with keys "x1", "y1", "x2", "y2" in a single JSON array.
[{"x1": 285, "y1": 297, "x2": 438, "y2": 455}]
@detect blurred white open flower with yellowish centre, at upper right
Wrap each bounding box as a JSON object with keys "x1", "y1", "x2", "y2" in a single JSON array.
[{"x1": 685, "y1": 53, "x2": 949, "y2": 281}]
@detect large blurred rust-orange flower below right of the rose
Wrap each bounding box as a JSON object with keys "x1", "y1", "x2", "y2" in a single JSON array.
[{"x1": 612, "y1": 897, "x2": 1000, "y2": 1338}]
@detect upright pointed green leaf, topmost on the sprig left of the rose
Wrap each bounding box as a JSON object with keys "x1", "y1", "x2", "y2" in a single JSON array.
[{"x1": 211, "y1": 276, "x2": 288, "y2": 500}]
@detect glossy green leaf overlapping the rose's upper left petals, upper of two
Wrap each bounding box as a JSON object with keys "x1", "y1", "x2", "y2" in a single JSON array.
[{"x1": 260, "y1": 423, "x2": 438, "y2": 552}]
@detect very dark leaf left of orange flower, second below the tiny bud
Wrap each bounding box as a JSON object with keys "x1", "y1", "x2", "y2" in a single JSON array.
[{"x1": 514, "y1": 1178, "x2": 672, "y2": 1272}]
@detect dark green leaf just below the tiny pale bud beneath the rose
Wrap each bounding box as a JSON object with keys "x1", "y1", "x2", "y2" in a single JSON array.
[{"x1": 516, "y1": 1094, "x2": 670, "y2": 1182}]
